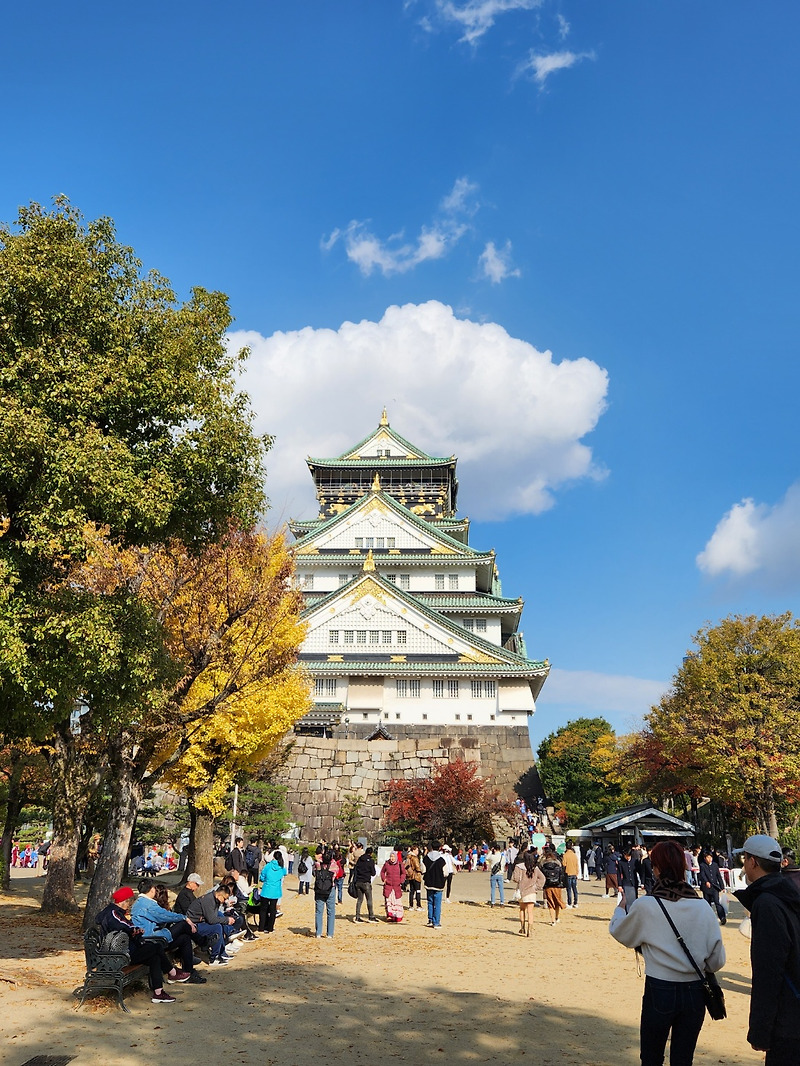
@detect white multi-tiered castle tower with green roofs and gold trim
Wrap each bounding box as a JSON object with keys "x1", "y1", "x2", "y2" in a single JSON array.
[{"x1": 291, "y1": 410, "x2": 549, "y2": 733}]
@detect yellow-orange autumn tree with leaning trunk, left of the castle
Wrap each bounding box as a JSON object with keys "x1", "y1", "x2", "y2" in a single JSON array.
[{"x1": 85, "y1": 529, "x2": 309, "y2": 922}]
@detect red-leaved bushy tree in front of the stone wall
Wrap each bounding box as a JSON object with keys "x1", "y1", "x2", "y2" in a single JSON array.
[{"x1": 386, "y1": 759, "x2": 515, "y2": 840}]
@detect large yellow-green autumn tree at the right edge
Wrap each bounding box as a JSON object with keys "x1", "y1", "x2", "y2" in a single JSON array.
[{"x1": 639, "y1": 613, "x2": 800, "y2": 836}]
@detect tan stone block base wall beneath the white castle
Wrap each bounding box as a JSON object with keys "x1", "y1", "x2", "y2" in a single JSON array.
[{"x1": 282, "y1": 725, "x2": 533, "y2": 840}]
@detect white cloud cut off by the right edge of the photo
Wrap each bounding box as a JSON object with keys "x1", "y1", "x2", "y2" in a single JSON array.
[{"x1": 697, "y1": 483, "x2": 800, "y2": 582}]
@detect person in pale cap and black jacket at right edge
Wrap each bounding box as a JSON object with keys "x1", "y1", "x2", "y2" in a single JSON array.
[{"x1": 734, "y1": 834, "x2": 800, "y2": 1066}]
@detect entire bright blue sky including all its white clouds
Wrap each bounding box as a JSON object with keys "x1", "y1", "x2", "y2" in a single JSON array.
[{"x1": 0, "y1": 0, "x2": 800, "y2": 740}]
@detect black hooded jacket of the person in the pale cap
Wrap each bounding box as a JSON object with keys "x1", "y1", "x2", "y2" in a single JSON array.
[{"x1": 734, "y1": 873, "x2": 800, "y2": 1049}]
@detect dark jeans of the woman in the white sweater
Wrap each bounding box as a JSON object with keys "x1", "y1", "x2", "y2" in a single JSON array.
[{"x1": 640, "y1": 978, "x2": 705, "y2": 1066}]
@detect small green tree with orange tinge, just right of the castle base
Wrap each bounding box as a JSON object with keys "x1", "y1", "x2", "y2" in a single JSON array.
[{"x1": 537, "y1": 717, "x2": 621, "y2": 825}]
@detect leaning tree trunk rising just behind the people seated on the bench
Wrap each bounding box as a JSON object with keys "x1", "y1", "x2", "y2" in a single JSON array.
[{"x1": 83, "y1": 739, "x2": 144, "y2": 930}]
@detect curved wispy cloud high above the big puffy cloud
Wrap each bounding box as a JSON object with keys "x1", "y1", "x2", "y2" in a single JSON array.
[{"x1": 320, "y1": 178, "x2": 480, "y2": 277}]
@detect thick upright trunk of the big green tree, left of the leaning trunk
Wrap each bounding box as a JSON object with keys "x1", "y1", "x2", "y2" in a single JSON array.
[{"x1": 42, "y1": 723, "x2": 106, "y2": 915}]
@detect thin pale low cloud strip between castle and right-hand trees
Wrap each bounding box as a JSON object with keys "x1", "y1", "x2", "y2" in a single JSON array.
[{"x1": 539, "y1": 667, "x2": 669, "y2": 716}]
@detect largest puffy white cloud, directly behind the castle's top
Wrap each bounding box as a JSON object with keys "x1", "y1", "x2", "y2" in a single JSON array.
[{"x1": 229, "y1": 301, "x2": 608, "y2": 519}]
